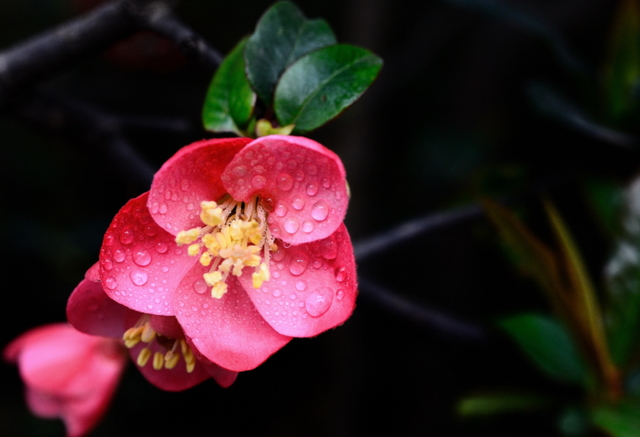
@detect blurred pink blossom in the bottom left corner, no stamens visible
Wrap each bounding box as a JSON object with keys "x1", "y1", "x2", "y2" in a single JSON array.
[{"x1": 4, "y1": 323, "x2": 126, "y2": 437}]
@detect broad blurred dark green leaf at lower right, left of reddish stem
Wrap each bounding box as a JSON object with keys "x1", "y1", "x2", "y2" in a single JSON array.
[{"x1": 498, "y1": 314, "x2": 587, "y2": 384}]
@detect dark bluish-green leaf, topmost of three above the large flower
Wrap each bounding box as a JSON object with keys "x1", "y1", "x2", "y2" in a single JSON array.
[{"x1": 244, "y1": 2, "x2": 337, "y2": 105}]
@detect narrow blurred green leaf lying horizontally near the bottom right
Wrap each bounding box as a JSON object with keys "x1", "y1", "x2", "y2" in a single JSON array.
[{"x1": 457, "y1": 393, "x2": 549, "y2": 416}]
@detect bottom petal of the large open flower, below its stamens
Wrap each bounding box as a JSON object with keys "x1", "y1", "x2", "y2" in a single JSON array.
[{"x1": 174, "y1": 263, "x2": 291, "y2": 372}]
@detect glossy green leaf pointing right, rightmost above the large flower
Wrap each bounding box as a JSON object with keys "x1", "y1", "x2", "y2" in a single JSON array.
[{"x1": 274, "y1": 44, "x2": 382, "y2": 133}]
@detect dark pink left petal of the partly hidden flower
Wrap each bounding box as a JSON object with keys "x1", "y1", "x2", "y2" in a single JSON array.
[{"x1": 67, "y1": 278, "x2": 130, "y2": 338}]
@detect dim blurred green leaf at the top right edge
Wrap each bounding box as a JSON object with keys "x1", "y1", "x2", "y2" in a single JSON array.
[{"x1": 606, "y1": 0, "x2": 640, "y2": 120}]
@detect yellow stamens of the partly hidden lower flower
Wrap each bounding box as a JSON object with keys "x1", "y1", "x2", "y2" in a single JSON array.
[{"x1": 122, "y1": 314, "x2": 196, "y2": 373}]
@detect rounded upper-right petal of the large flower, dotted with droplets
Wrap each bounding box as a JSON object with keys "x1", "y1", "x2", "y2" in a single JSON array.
[{"x1": 221, "y1": 135, "x2": 349, "y2": 244}]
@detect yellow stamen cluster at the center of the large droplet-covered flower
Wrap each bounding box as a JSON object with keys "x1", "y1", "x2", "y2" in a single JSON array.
[{"x1": 176, "y1": 195, "x2": 278, "y2": 299}]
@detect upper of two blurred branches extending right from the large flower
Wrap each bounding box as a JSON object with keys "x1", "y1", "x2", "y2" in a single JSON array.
[{"x1": 353, "y1": 204, "x2": 484, "y2": 261}]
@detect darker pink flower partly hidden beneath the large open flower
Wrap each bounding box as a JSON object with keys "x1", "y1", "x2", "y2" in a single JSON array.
[{"x1": 67, "y1": 263, "x2": 238, "y2": 391}]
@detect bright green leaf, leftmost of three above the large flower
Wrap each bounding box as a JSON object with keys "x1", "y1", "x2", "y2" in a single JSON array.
[{"x1": 202, "y1": 38, "x2": 256, "y2": 136}]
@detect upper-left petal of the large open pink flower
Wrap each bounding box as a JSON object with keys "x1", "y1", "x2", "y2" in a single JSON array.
[{"x1": 148, "y1": 138, "x2": 251, "y2": 235}]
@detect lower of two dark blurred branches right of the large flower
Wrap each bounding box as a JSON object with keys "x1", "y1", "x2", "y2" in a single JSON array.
[{"x1": 358, "y1": 276, "x2": 487, "y2": 341}]
